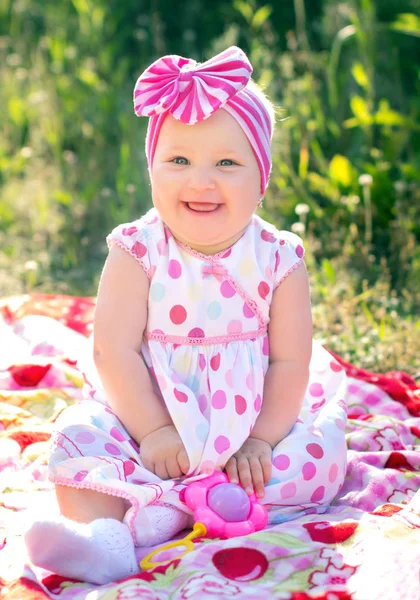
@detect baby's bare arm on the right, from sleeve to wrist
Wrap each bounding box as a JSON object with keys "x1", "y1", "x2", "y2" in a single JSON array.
[{"x1": 251, "y1": 262, "x2": 312, "y2": 448}]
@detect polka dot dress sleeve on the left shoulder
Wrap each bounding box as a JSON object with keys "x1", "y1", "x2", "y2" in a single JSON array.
[{"x1": 106, "y1": 221, "x2": 151, "y2": 279}]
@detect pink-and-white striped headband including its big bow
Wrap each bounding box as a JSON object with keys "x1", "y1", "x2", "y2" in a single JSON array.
[{"x1": 134, "y1": 46, "x2": 274, "y2": 195}]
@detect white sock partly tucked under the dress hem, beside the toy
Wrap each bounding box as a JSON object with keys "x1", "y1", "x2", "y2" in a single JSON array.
[{"x1": 131, "y1": 503, "x2": 194, "y2": 547}]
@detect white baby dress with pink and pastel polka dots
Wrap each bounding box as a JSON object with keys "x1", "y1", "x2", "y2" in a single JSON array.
[{"x1": 50, "y1": 209, "x2": 346, "y2": 528}]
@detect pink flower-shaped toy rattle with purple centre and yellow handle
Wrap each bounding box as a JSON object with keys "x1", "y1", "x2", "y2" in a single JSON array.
[{"x1": 140, "y1": 471, "x2": 268, "y2": 571}]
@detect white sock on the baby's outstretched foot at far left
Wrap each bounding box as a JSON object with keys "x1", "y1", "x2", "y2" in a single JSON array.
[{"x1": 24, "y1": 516, "x2": 139, "y2": 584}]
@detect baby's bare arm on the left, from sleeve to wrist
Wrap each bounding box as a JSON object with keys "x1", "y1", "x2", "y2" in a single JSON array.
[{"x1": 93, "y1": 246, "x2": 172, "y2": 444}]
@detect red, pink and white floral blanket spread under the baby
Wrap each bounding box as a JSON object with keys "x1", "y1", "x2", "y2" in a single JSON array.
[{"x1": 0, "y1": 295, "x2": 420, "y2": 600}]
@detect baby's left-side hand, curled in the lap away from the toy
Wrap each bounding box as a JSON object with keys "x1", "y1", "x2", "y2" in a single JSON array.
[{"x1": 140, "y1": 425, "x2": 190, "y2": 479}]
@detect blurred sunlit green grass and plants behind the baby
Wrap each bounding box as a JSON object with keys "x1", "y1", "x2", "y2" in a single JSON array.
[{"x1": 0, "y1": 0, "x2": 420, "y2": 374}]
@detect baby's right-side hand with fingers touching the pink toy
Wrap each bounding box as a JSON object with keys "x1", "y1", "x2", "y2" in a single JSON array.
[{"x1": 225, "y1": 438, "x2": 272, "y2": 498}]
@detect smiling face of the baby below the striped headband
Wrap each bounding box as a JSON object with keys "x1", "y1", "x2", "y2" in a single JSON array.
[{"x1": 151, "y1": 110, "x2": 260, "y2": 254}]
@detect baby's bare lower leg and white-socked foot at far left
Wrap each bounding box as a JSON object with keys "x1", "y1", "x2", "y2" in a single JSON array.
[{"x1": 25, "y1": 486, "x2": 138, "y2": 584}]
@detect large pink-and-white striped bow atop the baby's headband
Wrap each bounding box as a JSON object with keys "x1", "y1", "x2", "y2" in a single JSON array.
[{"x1": 134, "y1": 46, "x2": 252, "y2": 125}]
